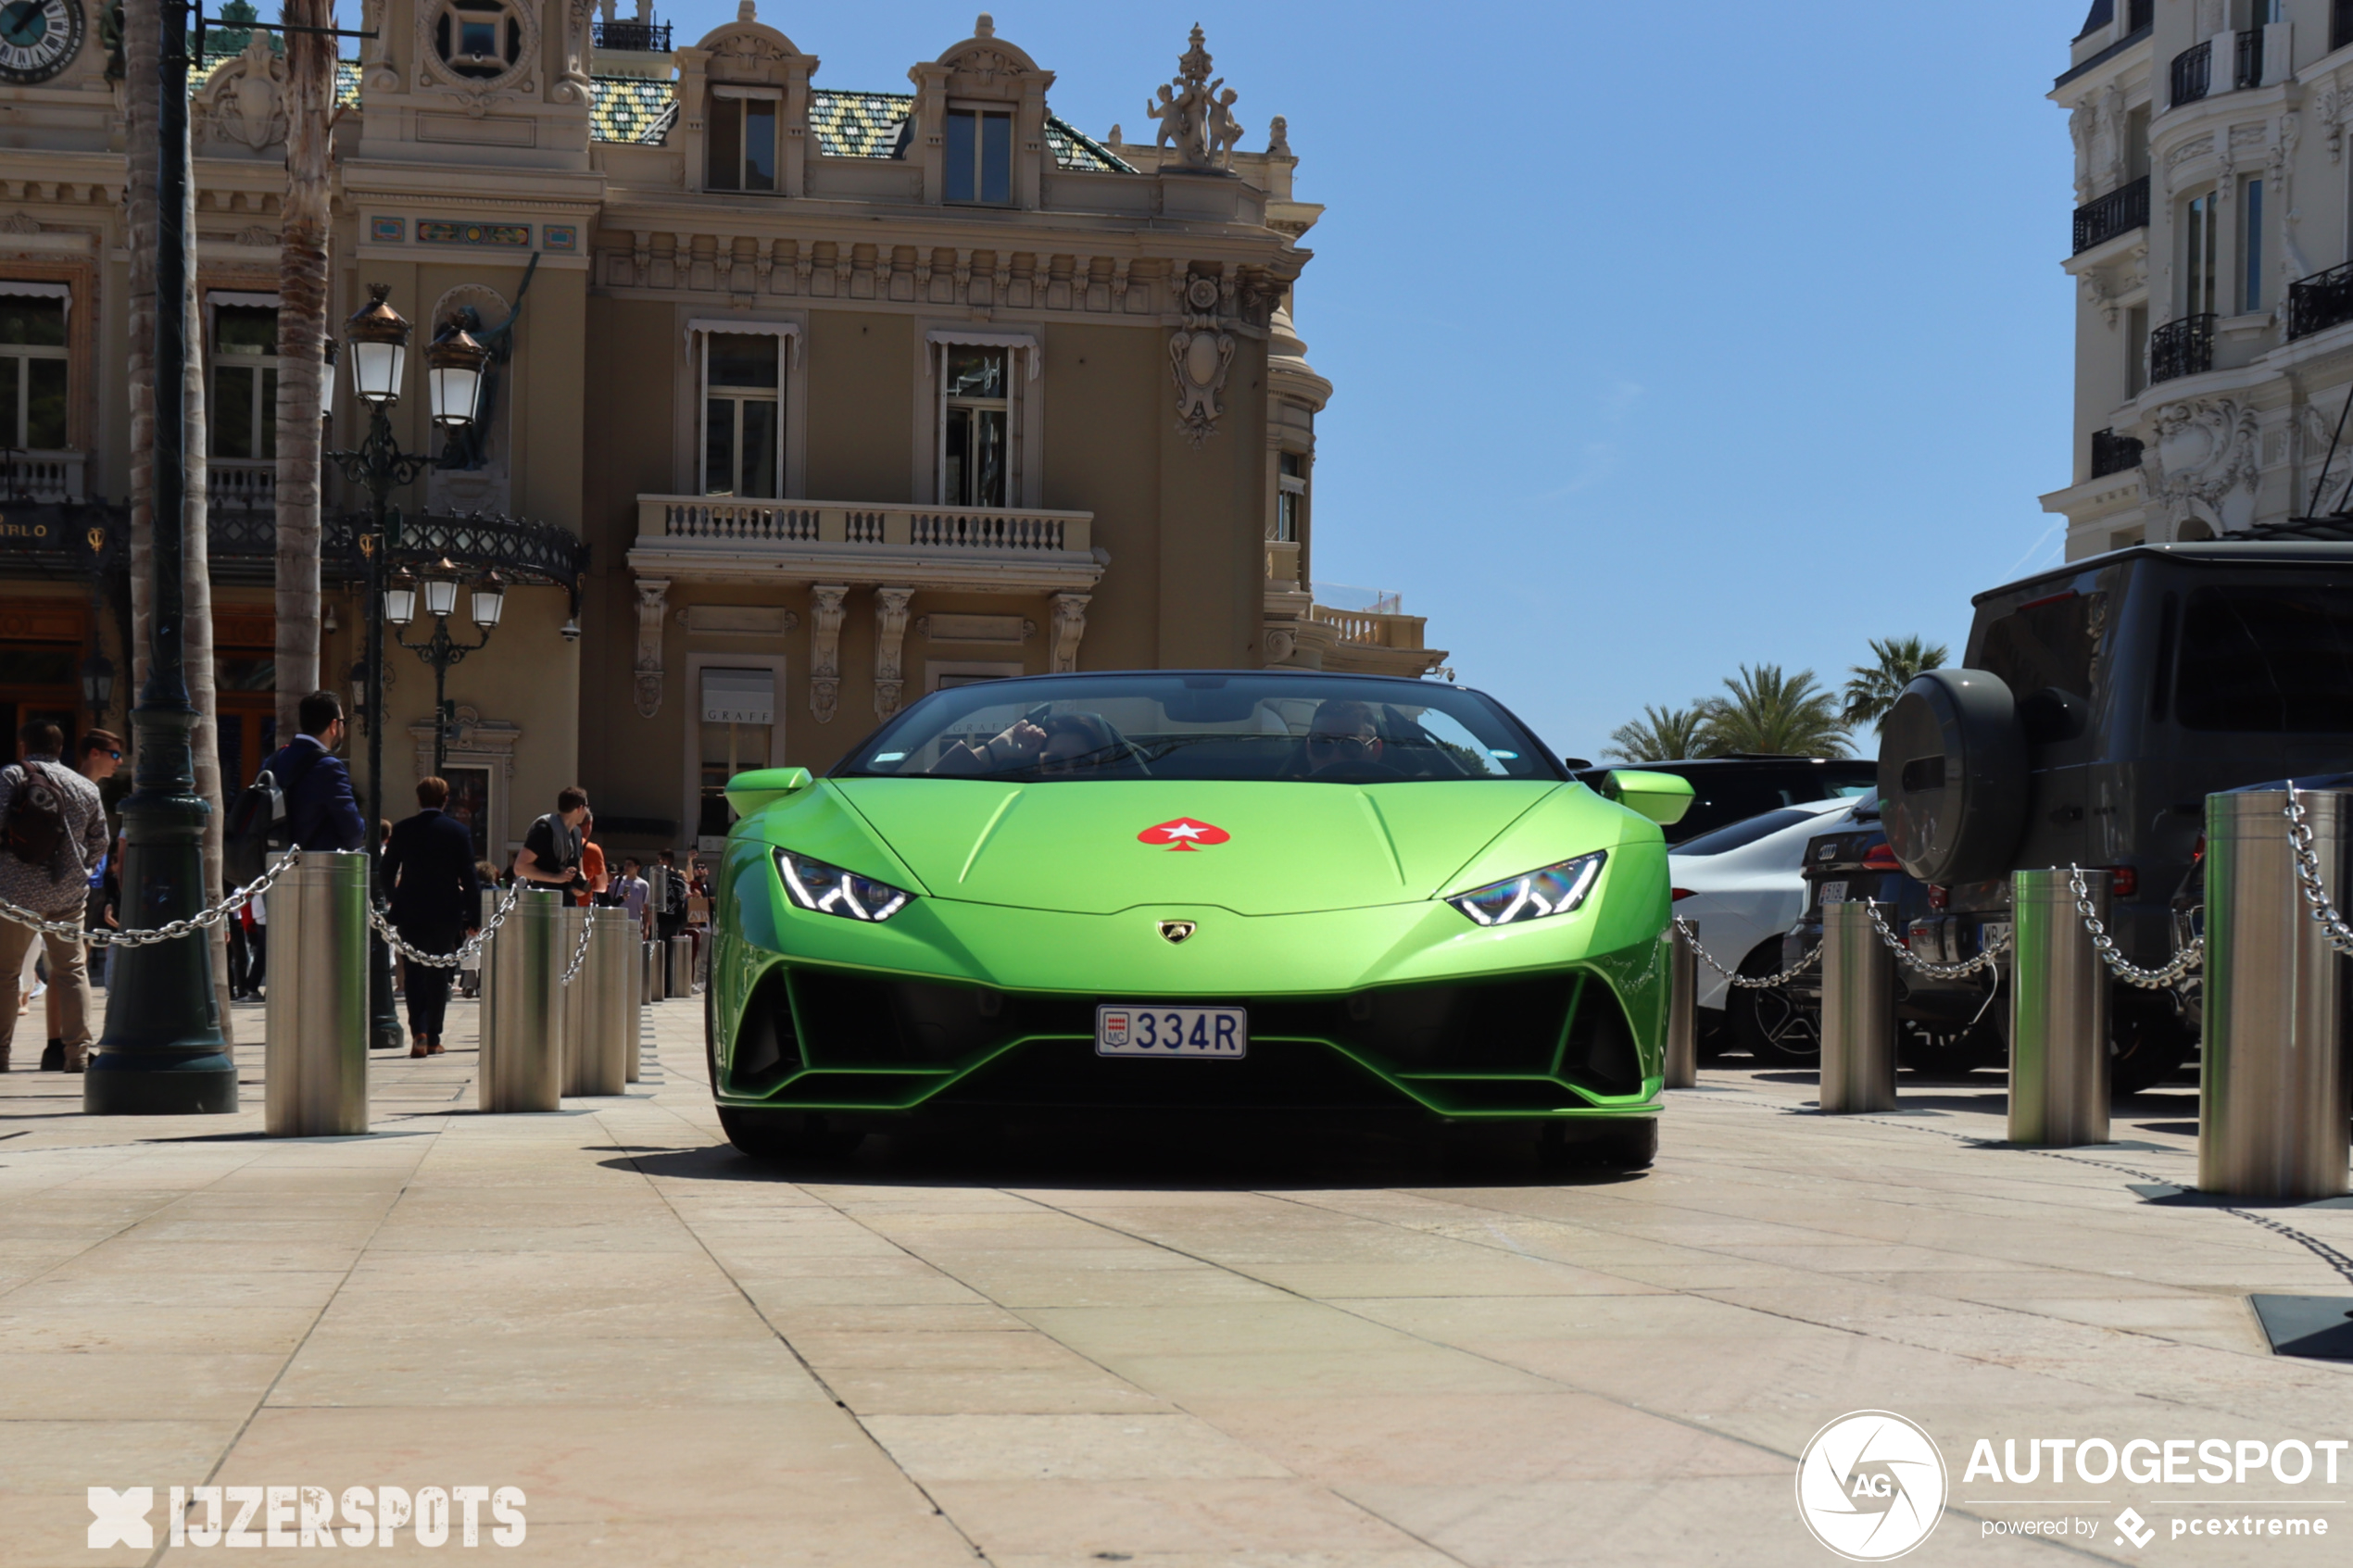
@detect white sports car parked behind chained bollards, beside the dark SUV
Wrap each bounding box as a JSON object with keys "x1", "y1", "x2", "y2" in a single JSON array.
[{"x1": 1666, "y1": 797, "x2": 1855, "y2": 1062}]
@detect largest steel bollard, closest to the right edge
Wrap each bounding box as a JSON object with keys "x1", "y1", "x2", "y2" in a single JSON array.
[{"x1": 2193, "y1": 790, "x2": 2346, "y2": 1198}]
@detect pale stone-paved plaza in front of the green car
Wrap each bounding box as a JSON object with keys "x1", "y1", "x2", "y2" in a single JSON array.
[{"x1": 0, "y1": 1001, "x2": 2353, "y2": 1568}]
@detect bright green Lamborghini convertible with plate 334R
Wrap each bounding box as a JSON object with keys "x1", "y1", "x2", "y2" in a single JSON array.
[{"x1": 709, "y1": 670, "x2": 1690, "y2": 1166}]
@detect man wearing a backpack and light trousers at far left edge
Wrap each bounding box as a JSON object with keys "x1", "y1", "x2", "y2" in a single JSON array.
[{"x1": 0, "y1": 720, "x2": 106, "y2": 1072}]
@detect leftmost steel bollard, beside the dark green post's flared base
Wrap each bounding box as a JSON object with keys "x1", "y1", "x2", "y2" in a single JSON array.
[{"x1": 261, "y1": 851, "x2": 367, "y2": 1138}]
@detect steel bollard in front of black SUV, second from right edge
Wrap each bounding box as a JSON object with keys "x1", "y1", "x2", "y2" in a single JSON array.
[{"x1": 2009, "y1": 868, "x2": 2108, "y2": 1149}]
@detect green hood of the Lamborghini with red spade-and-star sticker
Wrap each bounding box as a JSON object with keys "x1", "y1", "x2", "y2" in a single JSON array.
[{"x1": 828, "y1": 778, "x2": 1580, "y2": 914}]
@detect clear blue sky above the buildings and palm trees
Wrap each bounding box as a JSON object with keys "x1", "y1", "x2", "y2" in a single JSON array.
[{"x1": 362, "y1": 0, "x2": 2082, "y2": 757}]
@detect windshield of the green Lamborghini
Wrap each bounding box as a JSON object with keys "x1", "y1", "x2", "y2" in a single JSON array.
[{"x1": 833, "y1": 670, "x2": 1563, "y2": 785}]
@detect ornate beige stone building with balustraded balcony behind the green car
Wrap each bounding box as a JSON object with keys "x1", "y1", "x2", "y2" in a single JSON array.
[{"x1": 0, "y1": 0, "x2": 1445, "y2": 853}]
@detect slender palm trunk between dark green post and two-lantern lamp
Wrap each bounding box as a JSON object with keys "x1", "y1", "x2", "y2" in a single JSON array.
[{"x1": 278, "y1": 0, "x2": 334, "y2": 741}]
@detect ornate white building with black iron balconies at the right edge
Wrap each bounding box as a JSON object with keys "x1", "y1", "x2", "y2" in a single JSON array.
[{"x1": 2043, "y1": 0, "x2": 2353, "y2": 559}]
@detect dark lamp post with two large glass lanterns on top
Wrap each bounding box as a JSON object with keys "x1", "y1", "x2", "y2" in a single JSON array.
[{"x1": 327, "y1": 282, "x2": 487, "y2": 1051}]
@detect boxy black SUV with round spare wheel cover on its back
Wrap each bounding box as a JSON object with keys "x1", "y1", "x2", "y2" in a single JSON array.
[{"x1": 1880, "y1": 541, "x2": 2353, "y2": 1088}]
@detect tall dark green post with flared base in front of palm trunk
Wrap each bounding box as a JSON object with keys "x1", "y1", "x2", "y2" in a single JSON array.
[{"x1": 82, "y1": 0, "x2": 238, "y2": 1117}]
